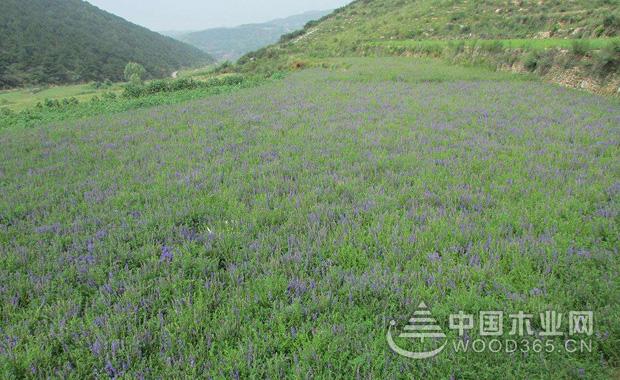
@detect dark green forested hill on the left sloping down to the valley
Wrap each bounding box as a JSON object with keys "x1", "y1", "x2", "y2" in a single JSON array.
[{"x1": 0, "y1": 0, "x2": 212, "y2": 88}]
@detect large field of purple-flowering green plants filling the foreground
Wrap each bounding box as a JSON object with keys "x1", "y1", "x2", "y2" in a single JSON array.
[{"x1": 0, "y1": 58, "x2": 620, "y2": 379}]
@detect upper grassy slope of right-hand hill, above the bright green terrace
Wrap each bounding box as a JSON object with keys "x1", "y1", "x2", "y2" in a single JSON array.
[{"x1": 241, "y1": 0, "x2": 620, "y2": 68}]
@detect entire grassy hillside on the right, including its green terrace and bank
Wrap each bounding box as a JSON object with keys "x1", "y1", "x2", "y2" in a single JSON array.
[{"x1": 240, "y1": 0, "x2": 620, "y2": 86}]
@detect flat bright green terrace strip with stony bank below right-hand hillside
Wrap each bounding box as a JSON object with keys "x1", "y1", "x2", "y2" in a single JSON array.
[{"x1": 348, "y1": 38, "x2": 620, "y2": 84}]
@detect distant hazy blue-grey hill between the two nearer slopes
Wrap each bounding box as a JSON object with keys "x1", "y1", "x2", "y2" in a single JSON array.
[{"x1": 173, "y1": 11, "x2": 331, "y2": 61}]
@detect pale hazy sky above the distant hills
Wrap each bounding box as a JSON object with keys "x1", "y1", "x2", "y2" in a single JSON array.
[{"x1": 88, "y1": 0, "x2": 352, "y2": 31}]
